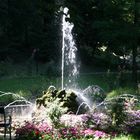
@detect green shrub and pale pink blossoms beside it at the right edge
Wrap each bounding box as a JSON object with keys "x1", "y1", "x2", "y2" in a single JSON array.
[{"x1": 106, "y1": 94, "x2": 140, "y2": 133}]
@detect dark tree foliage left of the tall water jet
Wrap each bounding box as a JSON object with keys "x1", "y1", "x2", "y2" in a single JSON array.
[{"x1": 0, "y1": 0, "x2": 59, "y2": 62}]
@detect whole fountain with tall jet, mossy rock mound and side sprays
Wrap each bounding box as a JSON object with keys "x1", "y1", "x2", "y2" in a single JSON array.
[{"x1": 0, "y1": 7, "x2": 104, "y2": 120}]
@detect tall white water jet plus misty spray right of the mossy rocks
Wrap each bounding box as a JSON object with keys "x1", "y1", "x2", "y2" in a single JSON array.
[{"x1": 61, "y1": 7, "x2": 105, "y2": 114}]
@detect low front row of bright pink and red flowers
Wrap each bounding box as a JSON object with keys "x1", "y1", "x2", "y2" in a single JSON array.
[{"x1": 16, "y1": 122, "x2": 112, "y2": 140}]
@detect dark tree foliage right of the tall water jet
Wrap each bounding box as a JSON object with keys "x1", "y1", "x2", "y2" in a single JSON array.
[{"x1": 65, "y1": 0, "x2": 140, "y2": 83}]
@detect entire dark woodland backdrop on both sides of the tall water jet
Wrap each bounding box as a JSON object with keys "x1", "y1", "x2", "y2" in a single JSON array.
[{"x1": 0, "y1": 0, "x2": 140, "y2": 86}]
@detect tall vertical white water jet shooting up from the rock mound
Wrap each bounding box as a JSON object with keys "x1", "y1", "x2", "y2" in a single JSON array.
[{"x1": 61, "y1": 7, "x2": 79, "y2": 89}]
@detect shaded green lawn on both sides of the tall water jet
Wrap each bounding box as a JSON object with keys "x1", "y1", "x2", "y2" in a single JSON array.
[{"x1": 0, "y1": 73, "x2": 138, "y2": 97}]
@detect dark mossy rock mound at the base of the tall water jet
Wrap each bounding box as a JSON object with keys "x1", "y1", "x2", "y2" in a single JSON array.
[{"x1": 36, "y1": 86, "x2": 78, "y2": 113}]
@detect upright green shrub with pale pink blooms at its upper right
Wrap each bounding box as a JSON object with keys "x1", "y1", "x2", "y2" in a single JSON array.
[{"x1": 105, "y1": 94, "x2": 139, "y2": 132}]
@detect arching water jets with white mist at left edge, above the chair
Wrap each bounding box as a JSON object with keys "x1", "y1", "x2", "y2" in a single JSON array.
[{"x1": 0, "y1": 91, "x2": 33, "y2": 119}]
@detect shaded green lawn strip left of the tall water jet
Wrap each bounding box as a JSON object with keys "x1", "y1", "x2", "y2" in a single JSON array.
[{"x1": 0, "y1": 76, "x2": 60, "y2": 98}]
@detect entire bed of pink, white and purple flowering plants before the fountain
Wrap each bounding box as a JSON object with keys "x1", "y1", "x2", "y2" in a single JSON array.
[{"x1": 13, "y1": 92, "x2": 140, "y2": 140}]
